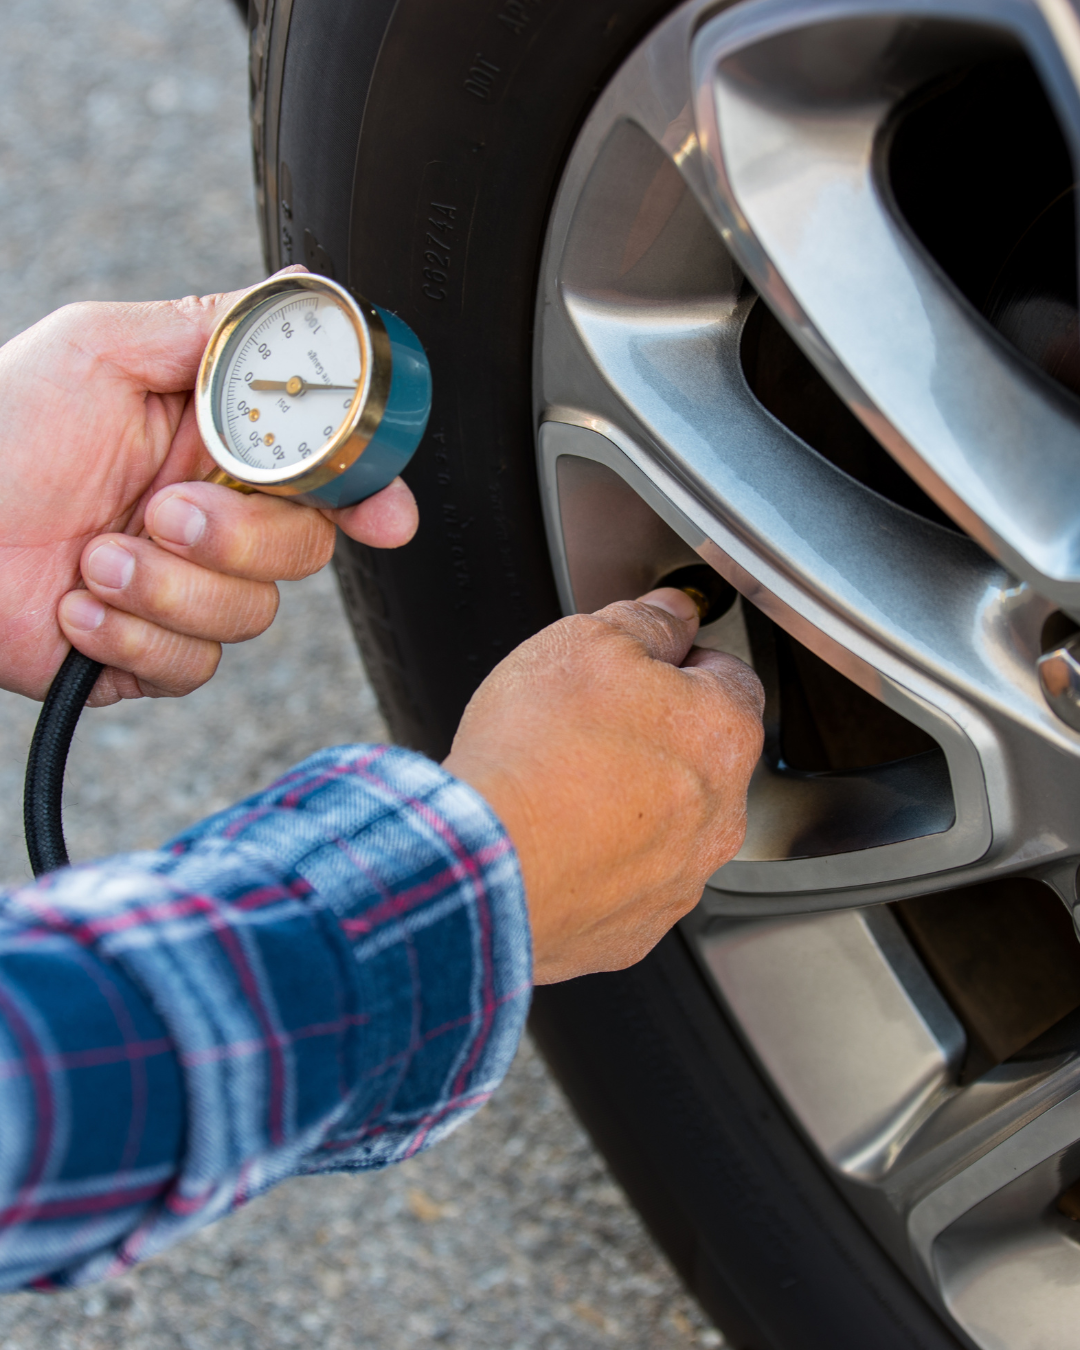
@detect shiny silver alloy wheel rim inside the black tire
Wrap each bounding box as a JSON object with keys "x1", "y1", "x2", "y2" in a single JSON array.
[{"x1": 535, "y1": 0, "x2": 1080, "y2": 1350}]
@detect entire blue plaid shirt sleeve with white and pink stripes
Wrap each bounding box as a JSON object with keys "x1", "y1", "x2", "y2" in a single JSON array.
[{"x1": 0, "y1": 745, "x2": 531, "y2": 1289}]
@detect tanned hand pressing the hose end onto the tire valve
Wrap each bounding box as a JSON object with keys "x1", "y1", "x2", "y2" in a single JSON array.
[{"x1": 446, "y1": 587, "x2": 764, "y2": 984}]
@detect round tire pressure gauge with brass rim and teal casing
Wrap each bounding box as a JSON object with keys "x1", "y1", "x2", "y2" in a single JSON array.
[{"x1": 196, "y1": 273, "x2": 431, "y2": 506}]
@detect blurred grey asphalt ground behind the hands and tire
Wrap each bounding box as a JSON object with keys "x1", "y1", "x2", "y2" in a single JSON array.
[{"x1": 0, "y1": 0, "x2": 721, "y2": 1350}]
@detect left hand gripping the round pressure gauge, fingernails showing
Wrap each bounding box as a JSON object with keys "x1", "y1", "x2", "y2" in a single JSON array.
[{"x1": 0, "y1": 267, "x2": 417, "y2": 703}]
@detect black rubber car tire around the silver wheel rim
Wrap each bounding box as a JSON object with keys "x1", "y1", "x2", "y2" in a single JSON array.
[{"x1": 251, "y1": 0, "x2": 967, "y2": 1350}]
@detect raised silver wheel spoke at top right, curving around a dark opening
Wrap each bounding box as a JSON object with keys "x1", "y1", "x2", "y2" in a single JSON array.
[{"x1": 694, "y1": 0, "x2": 1080, "y2": 613}]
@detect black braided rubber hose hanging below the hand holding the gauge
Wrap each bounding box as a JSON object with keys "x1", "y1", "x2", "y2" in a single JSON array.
[{"x1": 23, "y1": 648, "x2": 104, "y2": 876}]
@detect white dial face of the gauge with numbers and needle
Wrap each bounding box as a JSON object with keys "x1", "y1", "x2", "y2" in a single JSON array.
[{"x1": 217, "y1": 290, "x2": 362, "y2": 471}]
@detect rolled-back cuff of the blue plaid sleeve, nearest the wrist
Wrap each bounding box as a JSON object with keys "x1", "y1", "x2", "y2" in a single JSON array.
[{"x1": 1, "y1": 745, "x2": 531, "y2": 1283}]
